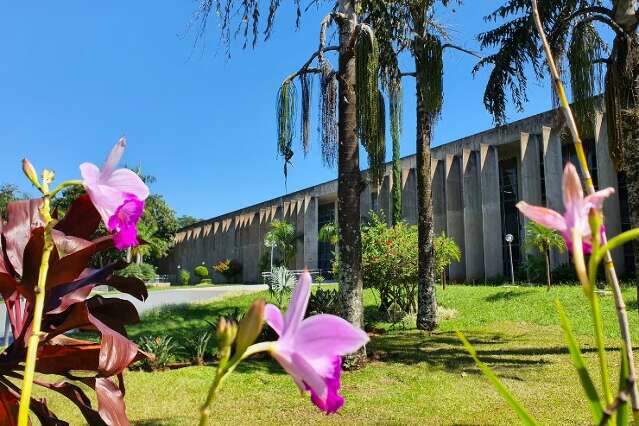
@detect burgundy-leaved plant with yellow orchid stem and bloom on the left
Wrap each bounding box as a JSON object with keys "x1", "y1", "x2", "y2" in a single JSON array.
[{"x1": 0, "y1": 139, "x2": 152, "y2": 426}]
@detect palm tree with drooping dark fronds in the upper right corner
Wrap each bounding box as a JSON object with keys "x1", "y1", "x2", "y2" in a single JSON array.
[{"x1": 475, "y1": 0, "x2": 639, "y2": 294}]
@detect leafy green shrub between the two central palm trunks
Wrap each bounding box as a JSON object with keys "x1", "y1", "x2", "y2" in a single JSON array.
[{"x1": 362, "y1": 213, "x2": 417, "y2": 313}]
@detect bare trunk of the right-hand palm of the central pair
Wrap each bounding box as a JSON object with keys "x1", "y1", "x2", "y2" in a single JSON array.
[{"x1": 414, "y1": 41, "x2": 437, "y2": 331}]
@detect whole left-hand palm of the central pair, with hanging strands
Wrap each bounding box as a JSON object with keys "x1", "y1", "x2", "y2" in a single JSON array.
[{"x1": 196, "y1": 0, "x2": 385, "y2": 360}]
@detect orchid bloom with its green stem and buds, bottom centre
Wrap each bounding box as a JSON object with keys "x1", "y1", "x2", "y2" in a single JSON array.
[{"x1": 200, "y1": 272, "x2": 368, "y2": 426}]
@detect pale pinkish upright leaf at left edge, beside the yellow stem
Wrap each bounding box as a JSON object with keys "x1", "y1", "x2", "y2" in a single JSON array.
[{"x1": 2, "y1": 198, "x2": 44, "y2": 275}]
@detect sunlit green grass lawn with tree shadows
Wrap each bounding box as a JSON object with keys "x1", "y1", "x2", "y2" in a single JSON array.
[{"x1": 38, "y1": 286, "x2": 639, "y2": 425}]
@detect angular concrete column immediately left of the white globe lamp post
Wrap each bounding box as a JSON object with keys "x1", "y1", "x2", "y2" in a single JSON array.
[{"x1": 479, "y1": 145, "x2": 504, "y2": 281}]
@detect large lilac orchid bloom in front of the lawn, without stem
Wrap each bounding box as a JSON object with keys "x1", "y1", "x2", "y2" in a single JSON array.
[{"x1": 264, "y1": 272, "x2": 368, "y2": 414}]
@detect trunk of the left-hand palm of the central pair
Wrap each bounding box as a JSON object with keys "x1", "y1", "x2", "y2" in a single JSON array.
[{"x1": 337, "y1": 0, "x2": 366, "y2": 364}]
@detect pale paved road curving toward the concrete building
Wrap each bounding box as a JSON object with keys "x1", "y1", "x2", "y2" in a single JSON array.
[{"x1": 0, "y1": 284, "x2": 267, "y2": 344}]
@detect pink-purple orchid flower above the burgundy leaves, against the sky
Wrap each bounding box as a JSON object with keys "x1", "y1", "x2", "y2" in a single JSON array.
[{"x1": 80, "y1": 138, "x2": 149, "y2": 250}]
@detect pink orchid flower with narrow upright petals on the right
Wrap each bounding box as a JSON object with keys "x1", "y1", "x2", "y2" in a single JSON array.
[{"x1": 517, "y1": 163, "x2": 615, "y2": 253}]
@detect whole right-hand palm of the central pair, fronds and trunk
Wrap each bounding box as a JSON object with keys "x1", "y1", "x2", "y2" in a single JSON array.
[{"x1": 362, "y1": 0, "x2": 472, "y2": 330}]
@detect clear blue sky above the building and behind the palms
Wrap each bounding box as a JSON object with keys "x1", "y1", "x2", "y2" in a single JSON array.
[{"x1": 0, "y1": 0, "x2": 550, "y2": 218}]
